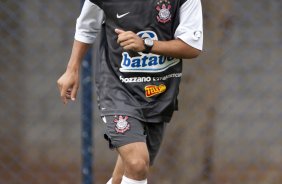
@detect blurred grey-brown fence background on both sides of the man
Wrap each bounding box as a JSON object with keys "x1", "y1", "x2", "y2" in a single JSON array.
[{"x1": 0, "y1": 0, "x2": 282, "y2": 184}]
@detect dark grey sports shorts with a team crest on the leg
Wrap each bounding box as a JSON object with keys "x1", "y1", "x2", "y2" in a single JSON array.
[{"x1": 102, "y1": 115, "x2": 166, "y2": 165}]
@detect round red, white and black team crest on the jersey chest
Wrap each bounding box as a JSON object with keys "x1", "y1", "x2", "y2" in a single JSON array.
[{"x1": 156, "y1": 0, "x2": 171, "y2": 24}]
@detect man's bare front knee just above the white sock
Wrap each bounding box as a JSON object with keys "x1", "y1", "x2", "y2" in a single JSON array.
[{"x1": 126, "y1": 158, "x2": 149, "y2": 177}]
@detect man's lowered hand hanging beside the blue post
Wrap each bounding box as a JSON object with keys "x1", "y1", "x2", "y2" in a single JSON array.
[{"x1": 57, "y1": 69, "x2": 79, "y2": 104}]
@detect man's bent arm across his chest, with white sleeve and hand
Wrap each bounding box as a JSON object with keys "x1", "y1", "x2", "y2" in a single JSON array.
[{"x1": 116, "y1": 0, "x2": 203, "y2": 59}]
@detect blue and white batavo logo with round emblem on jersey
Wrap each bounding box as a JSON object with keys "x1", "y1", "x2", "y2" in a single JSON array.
[{"x1": 120, "y1": 31, "x2": 180, "y2": 73}]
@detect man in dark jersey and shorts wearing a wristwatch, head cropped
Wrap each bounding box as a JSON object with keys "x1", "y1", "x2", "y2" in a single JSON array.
[{"x1": 58, "y1": 0, "x2": 203, "y2": 184}]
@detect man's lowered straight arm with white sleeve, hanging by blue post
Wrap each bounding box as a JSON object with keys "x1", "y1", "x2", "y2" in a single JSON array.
[{"x1": 57, "y1": 0, "x2": 104, "y2": 104}]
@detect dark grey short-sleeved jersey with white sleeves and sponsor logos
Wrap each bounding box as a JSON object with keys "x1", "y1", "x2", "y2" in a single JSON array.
[{"x1": 75, "y1": 0, "x2": 203, "y2": 122}]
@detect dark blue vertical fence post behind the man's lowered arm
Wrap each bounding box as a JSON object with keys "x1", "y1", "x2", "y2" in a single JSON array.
[{"x1": 81, "y1": 0, "x2": 93, "y2": 184}]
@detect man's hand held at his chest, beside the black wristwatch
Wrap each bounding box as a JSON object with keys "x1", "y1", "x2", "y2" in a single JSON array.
[{"x1": 115, "y1": 29, "x2": 145, "y2": 52}]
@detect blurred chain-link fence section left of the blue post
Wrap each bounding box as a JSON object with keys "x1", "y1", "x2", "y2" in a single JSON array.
[{"x1": 0, "y1": 0, "x2": 81, "y2": 184}]
